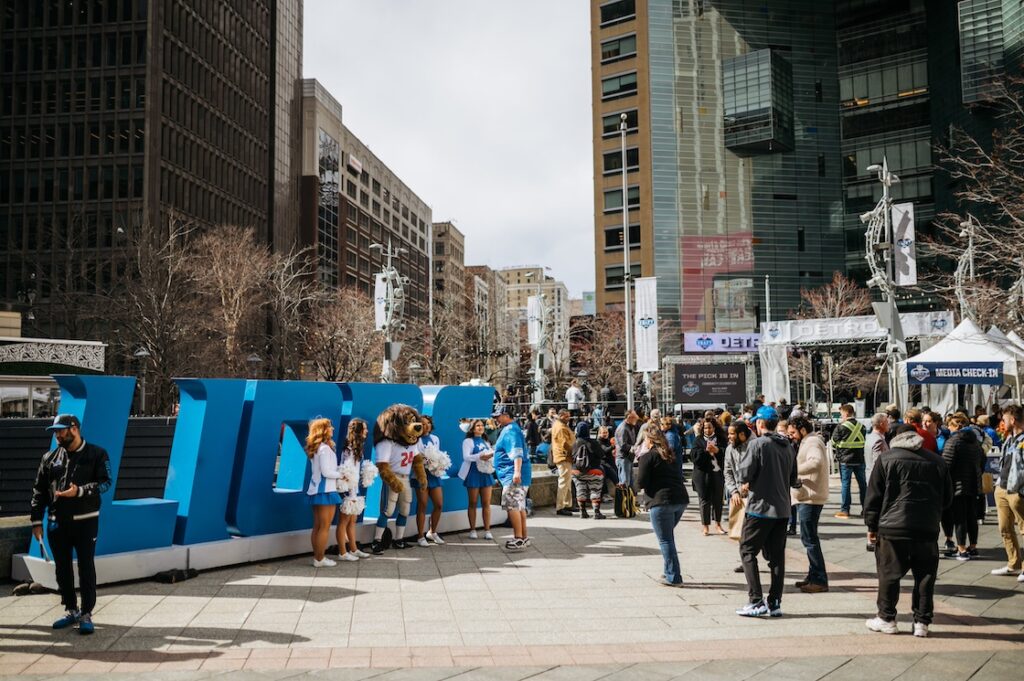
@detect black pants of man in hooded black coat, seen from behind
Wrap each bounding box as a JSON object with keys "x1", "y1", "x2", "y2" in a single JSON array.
[{"x1": 874, "y1": 535, "x2": 939, "y2": 625}]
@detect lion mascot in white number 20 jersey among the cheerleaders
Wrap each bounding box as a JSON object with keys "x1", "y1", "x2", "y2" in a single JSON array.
[{"x1": 371, "y1": 405, "x2": 427, "y2": 555}]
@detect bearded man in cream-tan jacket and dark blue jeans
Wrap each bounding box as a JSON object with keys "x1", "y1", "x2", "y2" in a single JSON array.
[{"x1": 786, "y1": 416, "x2": 828, "y2": 594}]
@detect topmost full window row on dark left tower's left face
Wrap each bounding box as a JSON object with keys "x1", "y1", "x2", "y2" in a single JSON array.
[{"x1": 0, "y1": 31, "x2": 146, "y2": 75}]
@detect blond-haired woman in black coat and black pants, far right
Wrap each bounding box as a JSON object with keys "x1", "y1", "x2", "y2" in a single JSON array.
[{"x1": 942, "y1": 414, "x2": 985, "y2": 560}]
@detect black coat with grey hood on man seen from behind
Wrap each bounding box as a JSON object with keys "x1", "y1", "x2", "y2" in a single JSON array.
[{"x1": 864, "y1": 432, "x2": 953, "y2": 542}]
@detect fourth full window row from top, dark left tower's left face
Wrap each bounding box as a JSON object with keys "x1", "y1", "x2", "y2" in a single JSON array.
[{"x1": 0, "y1": 163, "x2": 143, "y2": 205}]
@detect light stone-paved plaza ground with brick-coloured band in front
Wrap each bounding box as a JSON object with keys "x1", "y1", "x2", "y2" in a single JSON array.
[{"x1": 0, "y1": 481, "x2": 1024, "y2": 681}]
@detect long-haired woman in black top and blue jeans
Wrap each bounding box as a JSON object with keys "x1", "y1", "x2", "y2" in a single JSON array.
[{"x1": 637, "y1": 428, "x2": 690, "y2": 587}]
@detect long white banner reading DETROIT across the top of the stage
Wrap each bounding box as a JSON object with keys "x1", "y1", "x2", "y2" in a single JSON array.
[{"x1": 761, "y1": 311, "x2": 953, "y2": 348}]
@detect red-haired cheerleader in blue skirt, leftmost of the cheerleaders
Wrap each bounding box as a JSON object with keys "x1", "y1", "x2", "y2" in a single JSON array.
[{"x1": 306, "y1": 419, "x2": 341, "y2": 567}]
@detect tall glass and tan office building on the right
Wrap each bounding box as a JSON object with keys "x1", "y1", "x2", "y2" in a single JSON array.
[{"x1": 592, "y1": 0, "x2": 1022, "y2": 351}]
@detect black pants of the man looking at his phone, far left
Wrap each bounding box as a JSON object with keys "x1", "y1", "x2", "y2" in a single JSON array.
[{"x1": 47, "y1": 517, "x2": 99, "y2": 614}]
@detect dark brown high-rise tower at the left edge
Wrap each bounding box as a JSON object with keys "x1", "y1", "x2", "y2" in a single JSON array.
[{"x1": 0, "y1": 0, "x2": 302, "y2": 334}]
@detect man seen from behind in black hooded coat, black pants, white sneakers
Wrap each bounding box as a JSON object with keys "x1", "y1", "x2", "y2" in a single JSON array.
[{"x1": 864, "y1": 424, "x2": 953, "y2": 638}]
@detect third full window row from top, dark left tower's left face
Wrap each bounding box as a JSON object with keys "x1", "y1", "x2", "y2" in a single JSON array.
[{"x1": 0, "y1": 119, "x2": 145, "y2": 161}]
